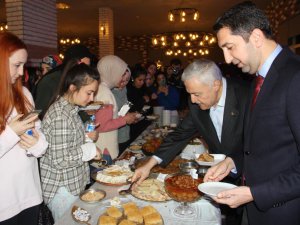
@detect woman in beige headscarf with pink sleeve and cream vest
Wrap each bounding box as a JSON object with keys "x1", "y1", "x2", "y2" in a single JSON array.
[{"x1": 96, "y1": 55, "x2": 137, "y2": 159}]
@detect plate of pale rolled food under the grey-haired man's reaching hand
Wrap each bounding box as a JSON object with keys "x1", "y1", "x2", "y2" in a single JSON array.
[{"x1": 131, "y1": 178, "x2": 170, "y2": 202}]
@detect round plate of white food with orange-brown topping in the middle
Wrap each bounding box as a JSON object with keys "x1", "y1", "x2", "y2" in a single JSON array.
[{"x1": 96, "y1": 165, "x2": 133, "y2": 185}]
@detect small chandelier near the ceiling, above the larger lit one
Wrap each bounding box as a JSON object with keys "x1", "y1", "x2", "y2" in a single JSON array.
[{"x1": 168, "y1": 8, "x2": 199, "y2": 23}]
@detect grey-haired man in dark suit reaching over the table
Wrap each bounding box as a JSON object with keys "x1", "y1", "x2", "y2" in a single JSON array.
[{"x1": 133, "y1": 59, "x2": 249, "y2": 224}]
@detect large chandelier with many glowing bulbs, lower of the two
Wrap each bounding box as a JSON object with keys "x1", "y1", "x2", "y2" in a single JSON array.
[{"x1": 151, "y1": 31, "x2": 216, "y2": 57}]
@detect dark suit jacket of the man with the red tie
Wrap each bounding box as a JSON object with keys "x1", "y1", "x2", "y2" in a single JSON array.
[{"x1": 234, "y1": 49, "x2": 300, "y2": 225}]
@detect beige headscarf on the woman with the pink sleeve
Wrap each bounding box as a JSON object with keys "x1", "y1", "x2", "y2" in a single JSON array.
[{"x1": 97, "y1": 55, "x2": 127, "y2": 89}]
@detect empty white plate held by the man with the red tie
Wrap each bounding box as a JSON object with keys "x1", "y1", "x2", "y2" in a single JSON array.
[{"x1": 198, "y1": 182, "x2": 237, "y2": 197}]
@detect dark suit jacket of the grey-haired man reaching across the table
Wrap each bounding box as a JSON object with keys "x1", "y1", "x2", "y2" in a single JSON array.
[{"x1": 155, "y1": 79, "x2": 250, "y2": 166}]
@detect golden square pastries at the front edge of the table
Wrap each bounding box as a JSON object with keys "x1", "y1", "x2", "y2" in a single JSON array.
[{"x1": 98, "y1": 202, "x2": 163, "y2": 225}]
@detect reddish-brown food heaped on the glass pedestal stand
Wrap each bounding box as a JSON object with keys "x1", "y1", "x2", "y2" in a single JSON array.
[{"x1": 165, "y1": 174, "x2": 203, "y2": 202}]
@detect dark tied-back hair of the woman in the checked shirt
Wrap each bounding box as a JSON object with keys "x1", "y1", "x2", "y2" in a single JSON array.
[{"x1": 48, "y1": 59, "x2": 100, "y2": 112}]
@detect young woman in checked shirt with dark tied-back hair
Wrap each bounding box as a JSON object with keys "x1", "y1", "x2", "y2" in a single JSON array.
[{"x1": 40, "y1": 63, "x2": 101, "y2": 221}]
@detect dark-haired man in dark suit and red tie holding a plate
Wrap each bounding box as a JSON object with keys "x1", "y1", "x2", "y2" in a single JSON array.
[{"x1": 204, "y1": 2, "x2": 300, "y2": 225}]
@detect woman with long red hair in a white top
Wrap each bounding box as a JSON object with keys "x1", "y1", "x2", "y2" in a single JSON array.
[{"x1": 0, "y1": 32, "x2": 48, "y2": 225}]
